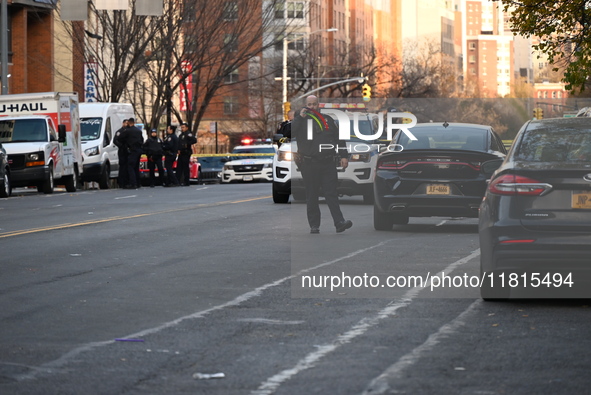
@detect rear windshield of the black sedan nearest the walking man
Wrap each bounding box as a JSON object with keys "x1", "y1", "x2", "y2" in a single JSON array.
[{"x1": 397, "y1": 125, "x2": 488, "y2": 151}]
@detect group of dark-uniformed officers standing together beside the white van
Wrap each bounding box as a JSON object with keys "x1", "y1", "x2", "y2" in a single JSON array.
[{"x1": 114, "y1": 118, "x2": 197, "y2": 189}]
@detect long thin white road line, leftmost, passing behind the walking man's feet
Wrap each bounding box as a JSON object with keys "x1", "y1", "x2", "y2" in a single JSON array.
[{"x1": 14, "y1": 240, "x2": 391, "y2": 381}]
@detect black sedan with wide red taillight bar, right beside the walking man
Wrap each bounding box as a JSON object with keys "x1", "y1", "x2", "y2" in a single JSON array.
[{"x1": 374, "y1": 122, "x2": 506, "y2": 230}]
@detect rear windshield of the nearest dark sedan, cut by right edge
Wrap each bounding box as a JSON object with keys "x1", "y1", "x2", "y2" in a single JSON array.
[{"x1": 514, "y1": 123, "x2": 591, "y2": 162}]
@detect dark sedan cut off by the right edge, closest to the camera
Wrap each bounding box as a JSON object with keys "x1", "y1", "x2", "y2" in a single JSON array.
[{"x1": 479, "y1": 118, "x2": 591, "y2": 299}]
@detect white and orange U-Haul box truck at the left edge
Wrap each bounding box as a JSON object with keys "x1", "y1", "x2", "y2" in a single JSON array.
[{"x1": 0, "y1": 92, "x2": 83, "y2": 193}]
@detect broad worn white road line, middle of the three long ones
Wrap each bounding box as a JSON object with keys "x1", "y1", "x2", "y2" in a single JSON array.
[{"x1": 251, "y1": 250, "x2": 480, "y2": 395}]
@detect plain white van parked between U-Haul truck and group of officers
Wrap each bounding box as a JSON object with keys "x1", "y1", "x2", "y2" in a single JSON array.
[{"x1": 79, "y1": 103, "x2": 134, "y2": 189}]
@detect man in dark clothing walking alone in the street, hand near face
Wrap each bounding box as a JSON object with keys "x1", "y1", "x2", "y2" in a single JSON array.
[{"x1": 291, "y1": 95, "x2": 353, "y2": 234}]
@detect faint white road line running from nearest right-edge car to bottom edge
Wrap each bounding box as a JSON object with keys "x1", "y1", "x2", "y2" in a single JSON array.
[{"x1": 363, "y1": 299, "x2": 482, "y2": 395}]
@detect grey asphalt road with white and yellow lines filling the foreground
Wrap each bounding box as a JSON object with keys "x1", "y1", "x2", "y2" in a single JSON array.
[{"x1": 0, "y1": 183, "x2": 591, "y2": 395}]
